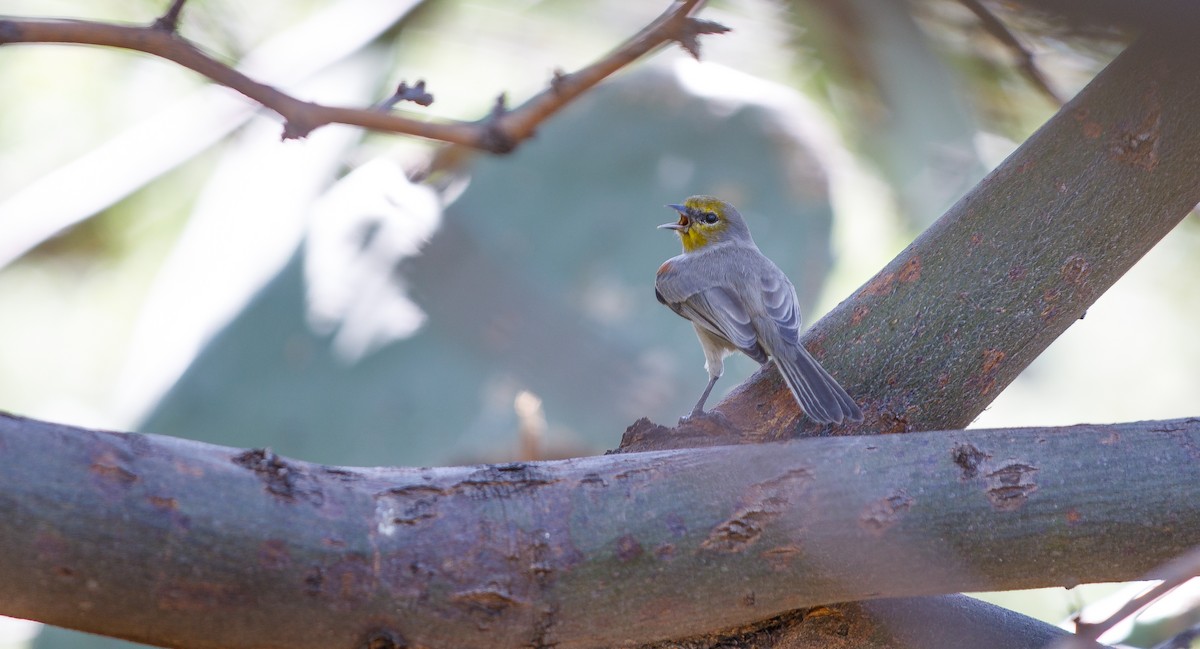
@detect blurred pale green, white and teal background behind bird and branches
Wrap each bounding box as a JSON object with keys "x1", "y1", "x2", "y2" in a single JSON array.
[{"x1": 0, "y1": 0, "x2": 1200, "y2": 647}]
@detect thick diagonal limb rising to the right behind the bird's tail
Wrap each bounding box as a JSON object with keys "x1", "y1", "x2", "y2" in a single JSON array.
[{"x1": 622, "y1": 26, "x2": 1200, "y2": 450}]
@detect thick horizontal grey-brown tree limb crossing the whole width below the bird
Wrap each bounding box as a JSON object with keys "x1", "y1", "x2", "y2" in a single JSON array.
[{"x1": 0, "y1": 416, "x2": 1200, "y2": 649}]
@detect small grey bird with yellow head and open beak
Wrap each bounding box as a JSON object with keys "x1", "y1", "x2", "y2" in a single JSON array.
[{"x1": 654, "y1": 196, "x2": 863, "y2": 423}]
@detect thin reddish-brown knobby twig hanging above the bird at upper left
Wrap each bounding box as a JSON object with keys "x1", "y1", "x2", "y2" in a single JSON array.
[{"x1": 0, "y1": 0, "x2": 728, "y2": 154}]
